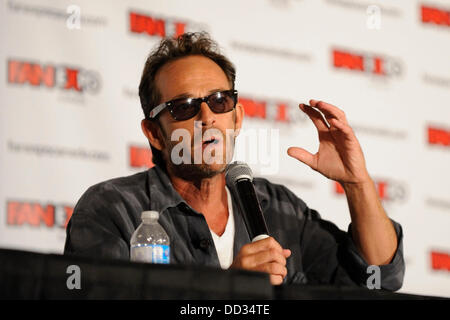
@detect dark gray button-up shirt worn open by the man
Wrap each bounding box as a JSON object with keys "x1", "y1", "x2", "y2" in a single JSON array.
[{"x1": 64, "y1": 166, "x2": 405, "y2": 290}]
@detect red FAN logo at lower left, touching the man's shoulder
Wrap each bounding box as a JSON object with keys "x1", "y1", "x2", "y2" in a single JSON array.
[{"x1": 7, "y1": 201, "x2": 73, "y2": 228}]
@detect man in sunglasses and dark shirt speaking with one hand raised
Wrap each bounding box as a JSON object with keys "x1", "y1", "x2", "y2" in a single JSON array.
[{"x1": 65, "y1": 33, "x2": 405, "y2": 290}]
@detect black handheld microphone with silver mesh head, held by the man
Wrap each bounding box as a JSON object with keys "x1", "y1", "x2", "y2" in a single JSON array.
[{"x1": 225, "y1": 161, "x2": 269, "y2": 242}]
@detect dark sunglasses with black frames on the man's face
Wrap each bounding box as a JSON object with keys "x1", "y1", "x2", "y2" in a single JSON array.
[{"x1": 149, "y1": 90, "x2": 237, "y2": 121}]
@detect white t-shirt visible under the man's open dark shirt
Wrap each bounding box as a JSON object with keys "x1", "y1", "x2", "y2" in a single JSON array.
[{"x1": 209, "y1": 186, "x2": 234, "y2": 269}]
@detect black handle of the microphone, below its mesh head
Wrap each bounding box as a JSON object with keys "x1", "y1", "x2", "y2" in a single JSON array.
[{"x1": 236, "y1": 179, "x2": 269, "y2": 242}]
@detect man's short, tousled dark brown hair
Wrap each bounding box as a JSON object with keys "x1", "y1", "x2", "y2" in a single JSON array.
[{"x1": 139, "y1": 32, "x2": 236, "y2": 169}]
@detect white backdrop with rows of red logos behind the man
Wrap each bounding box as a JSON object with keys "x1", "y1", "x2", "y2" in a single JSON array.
[{"x1": 0, "y1": 0, "x2": 450, "y2": 297}]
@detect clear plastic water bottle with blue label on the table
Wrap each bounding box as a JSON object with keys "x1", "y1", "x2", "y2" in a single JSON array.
[{"x1": 130, "y1": 211, "x2": 170, "y2": 263}]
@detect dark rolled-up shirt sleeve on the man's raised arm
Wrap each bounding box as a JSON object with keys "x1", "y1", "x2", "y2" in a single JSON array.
[{"x1": 301, "y1": 201, "x2": 405, "y2": 291}]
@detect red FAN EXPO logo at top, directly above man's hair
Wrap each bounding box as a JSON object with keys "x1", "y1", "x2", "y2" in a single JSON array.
[{"x1": 129, "y1": 11, "x2": 208, "y2": 38}]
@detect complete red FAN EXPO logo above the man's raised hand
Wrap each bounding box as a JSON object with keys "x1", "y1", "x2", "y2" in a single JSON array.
[{"x1": 332, "y1": 49, "x2": 401, "y2": 76}]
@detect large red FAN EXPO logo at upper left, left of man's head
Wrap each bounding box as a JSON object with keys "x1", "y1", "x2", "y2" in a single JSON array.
[{"x1": 8, "y1": 59, "x2": 100, "y2": 94}]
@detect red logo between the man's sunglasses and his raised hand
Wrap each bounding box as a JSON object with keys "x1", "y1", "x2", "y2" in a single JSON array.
[{"x1": 239, "y1": 97, "x2": 306, "y2": 123}]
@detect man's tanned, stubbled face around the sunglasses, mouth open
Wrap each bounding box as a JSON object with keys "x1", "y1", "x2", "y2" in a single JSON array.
[{"x1": 144, "y1": 56, "x2": 243, "y2": 180}]
